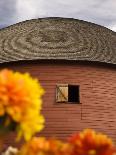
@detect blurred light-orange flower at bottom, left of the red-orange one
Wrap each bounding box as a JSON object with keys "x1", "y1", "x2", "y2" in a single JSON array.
[{"x1": 19, "y1": 137, "x2": 71, "y2": 155}]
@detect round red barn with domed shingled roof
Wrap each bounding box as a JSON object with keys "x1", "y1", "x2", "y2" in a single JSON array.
[{"x1": 0, "y1": 18, "x2": 116, "y2": 147}]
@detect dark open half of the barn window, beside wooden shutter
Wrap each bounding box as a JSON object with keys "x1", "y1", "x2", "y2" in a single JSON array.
[{"x1": 68, "y1": 85, "x2": 80, "y2": 103}]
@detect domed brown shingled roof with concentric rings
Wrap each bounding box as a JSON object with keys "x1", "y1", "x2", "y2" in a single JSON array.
[{"x1": 0, "y1": 17, "x2": 116, "y2": 64}]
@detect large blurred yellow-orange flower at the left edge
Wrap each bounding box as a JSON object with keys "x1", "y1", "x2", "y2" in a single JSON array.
[{"x1": 0, "y1": 69, "x2": 44, "y2": 140}]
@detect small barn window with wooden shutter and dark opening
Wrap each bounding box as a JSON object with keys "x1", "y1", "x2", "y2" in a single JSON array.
[{"x1": 56, "y1": 84, "x2": 80, "y2": 104}]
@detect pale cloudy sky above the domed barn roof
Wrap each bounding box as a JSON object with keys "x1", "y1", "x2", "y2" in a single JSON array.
[{"x1": 0, "y1": 0, "x2": 116, "y2": 32}]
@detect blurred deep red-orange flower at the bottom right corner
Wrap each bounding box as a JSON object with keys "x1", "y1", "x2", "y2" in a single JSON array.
[{"x1": 69, "y1": 129, "x2": 116, "y2": 155}]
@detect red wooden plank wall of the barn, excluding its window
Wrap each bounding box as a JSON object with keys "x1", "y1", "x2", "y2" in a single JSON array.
[{"x1": 0, "y1": 62, "x2": 116, "y2": 148}]
